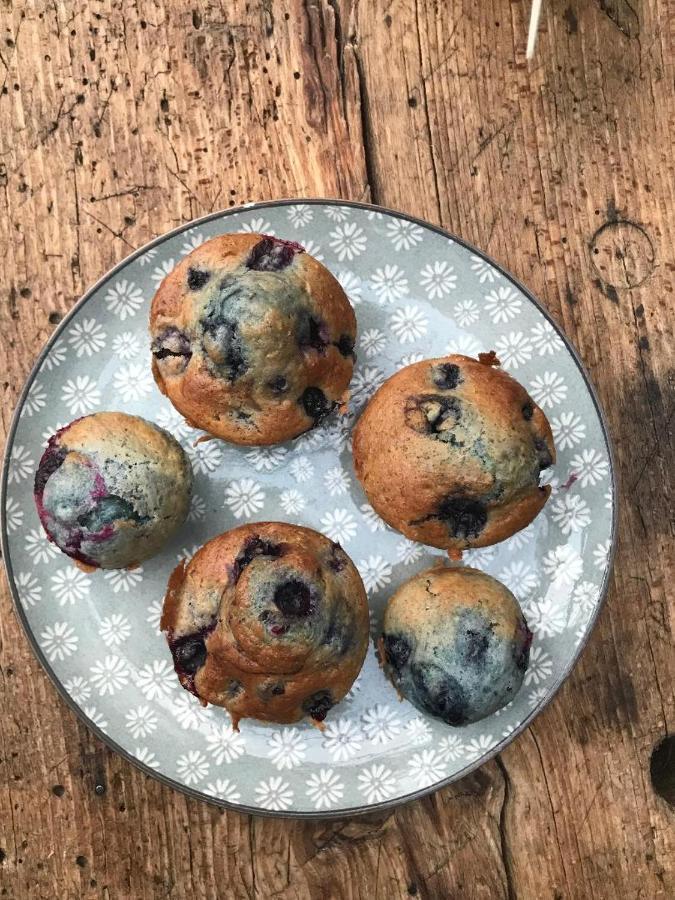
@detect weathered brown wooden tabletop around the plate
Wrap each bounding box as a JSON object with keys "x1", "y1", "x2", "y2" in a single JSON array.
[{"x1": 0, "y1": 0, "x2": 675, "y2": 900}]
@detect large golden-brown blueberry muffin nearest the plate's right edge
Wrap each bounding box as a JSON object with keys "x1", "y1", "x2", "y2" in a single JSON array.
[{"x1": 353, "y1": 354, "x2": 555, "y2": 556}]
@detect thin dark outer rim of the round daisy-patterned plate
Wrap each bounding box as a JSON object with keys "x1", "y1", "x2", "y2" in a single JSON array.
[{"x1": 0, "y1": 197, "x2": 619, "y2": 820}]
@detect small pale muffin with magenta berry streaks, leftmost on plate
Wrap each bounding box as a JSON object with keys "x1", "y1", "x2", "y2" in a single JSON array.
[{"x1": 35, "y1": 412, "x2": 192, "y2": 569}]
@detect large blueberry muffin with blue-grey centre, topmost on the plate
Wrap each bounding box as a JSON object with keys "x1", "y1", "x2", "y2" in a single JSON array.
[{"x1": 150, "y1": 234, "x2": 356, "y2": 444}]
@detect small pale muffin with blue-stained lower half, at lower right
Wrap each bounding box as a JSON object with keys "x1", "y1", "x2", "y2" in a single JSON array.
[{"x1": 379, "y1": 566, "x2": 532, "y2": 725}]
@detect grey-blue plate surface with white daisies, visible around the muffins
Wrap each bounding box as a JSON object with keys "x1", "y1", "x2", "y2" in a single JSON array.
[{"x1": 2, "y1": 201, "x2": 615, "y2": 816}]
